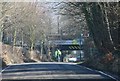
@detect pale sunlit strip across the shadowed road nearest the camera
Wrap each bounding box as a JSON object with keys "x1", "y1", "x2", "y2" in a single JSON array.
[{"x1": 3, "y1": 74, "x2": 104, "y2": 79}]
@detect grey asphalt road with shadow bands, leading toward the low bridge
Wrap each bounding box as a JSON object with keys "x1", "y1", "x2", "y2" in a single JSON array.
[{"x1": 2, "y1": 62, "x2": 116, "y2": 81}]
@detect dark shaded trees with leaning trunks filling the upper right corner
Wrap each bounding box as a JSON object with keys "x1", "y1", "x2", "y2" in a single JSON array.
[{"x1": 83, "y1": 3, "x2": 119, "y2": 53}]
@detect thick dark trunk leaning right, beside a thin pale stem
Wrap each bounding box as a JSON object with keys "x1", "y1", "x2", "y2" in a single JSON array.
[{"x1": 83, "y1": 3, "x2": 114, "y2": 53}]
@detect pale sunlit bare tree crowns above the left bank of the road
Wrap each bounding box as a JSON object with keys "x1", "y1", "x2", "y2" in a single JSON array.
[{"x1": 1, "y1": 2, "x2": 49, "y2": 52}]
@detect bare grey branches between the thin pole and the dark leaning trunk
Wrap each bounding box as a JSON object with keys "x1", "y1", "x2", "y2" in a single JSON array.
[{"x1": 53, "y1": 2, "x2": 88, "y2": 39}]
